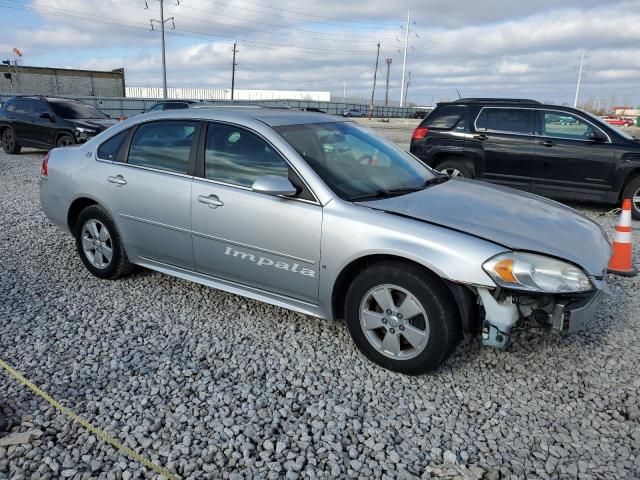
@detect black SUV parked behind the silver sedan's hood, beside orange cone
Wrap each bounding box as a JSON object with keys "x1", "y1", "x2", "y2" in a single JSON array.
[{"x1": 411, "y1": 98, "x2": 640, "y2": 219}]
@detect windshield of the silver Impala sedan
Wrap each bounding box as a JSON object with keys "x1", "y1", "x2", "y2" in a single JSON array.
[{"x1": 274, "y1": 122, "x2": 437, "y2": 200}]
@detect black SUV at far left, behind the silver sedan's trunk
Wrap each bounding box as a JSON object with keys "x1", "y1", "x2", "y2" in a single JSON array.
[{"x1": 0, "y1": 96, "x2": 117, "y2": 154}]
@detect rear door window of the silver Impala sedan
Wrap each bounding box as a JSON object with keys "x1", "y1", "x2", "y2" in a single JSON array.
[{"x1": 127, "y1": 120, "x2": 198, "y2": 174}]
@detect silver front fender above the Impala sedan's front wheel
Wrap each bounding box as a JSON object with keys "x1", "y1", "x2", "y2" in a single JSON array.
[{"x1": 319, "y1": 202, "x2": 508, "y2": 318}]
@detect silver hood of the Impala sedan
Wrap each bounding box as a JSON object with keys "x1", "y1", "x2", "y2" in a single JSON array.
[{"x1": 358, "y1": 178, "x2": 611, "y2": 277}]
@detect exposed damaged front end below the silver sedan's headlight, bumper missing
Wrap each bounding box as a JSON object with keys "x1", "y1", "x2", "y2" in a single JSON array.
[{"x1": 476, "y1": 282, "x2": 606, "y2": 349}]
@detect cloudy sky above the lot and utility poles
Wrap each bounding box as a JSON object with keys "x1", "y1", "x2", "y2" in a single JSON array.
[{"x1": 0, "y1": 0, "x2": 640, "y2": 106}]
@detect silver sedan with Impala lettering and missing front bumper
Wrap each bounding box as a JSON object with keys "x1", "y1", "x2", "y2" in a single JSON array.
[{"x1": 40, "y1": 107, "x2": 611, "y2": 374}]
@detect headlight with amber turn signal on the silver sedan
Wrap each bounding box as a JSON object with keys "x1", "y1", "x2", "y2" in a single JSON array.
[{"x1": 482, "y1": 252, "x2": 593, "y2": 293}]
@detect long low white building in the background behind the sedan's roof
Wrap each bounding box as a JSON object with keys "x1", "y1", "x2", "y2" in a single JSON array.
[{"x1": 126, "y1": 87, "x2": 331, "y2": 102}]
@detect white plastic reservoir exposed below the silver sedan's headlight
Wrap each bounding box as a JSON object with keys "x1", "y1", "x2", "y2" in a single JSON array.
[{"x1": 478, "y1": 288, "x2": 520, "y2": 349}]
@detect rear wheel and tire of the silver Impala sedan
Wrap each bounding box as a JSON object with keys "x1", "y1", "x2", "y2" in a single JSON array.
[{"x1": 75, "y1": 205, "x2": 133, "y2": 280}]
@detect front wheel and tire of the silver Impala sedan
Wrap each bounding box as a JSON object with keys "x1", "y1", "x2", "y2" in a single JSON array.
[{"x1": 345, "y1": 262, "x2": 461, "y2": 375}]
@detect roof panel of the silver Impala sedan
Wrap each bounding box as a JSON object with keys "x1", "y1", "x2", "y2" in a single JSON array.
[{"x1": 138, "y1": 106, "x2": 348, "y2": 127}]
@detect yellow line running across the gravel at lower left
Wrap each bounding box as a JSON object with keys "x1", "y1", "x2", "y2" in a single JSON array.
[{"x1": 0, "y1": 359, "x2": 178, "y2": 480}]
